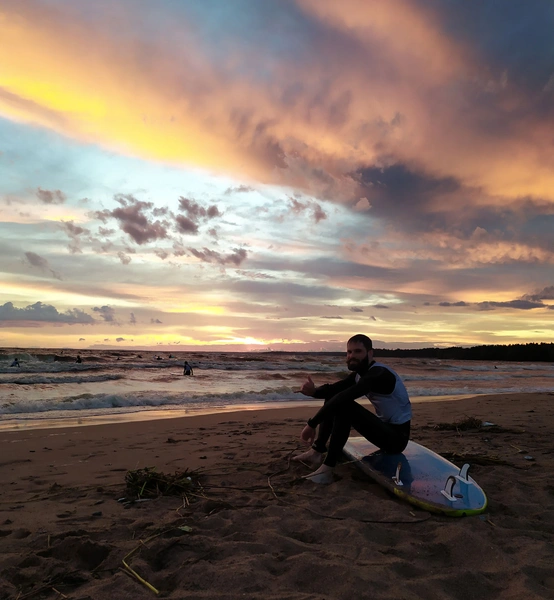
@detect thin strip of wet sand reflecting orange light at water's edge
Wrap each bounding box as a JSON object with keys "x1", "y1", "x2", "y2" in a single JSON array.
[{"x1": 0, "y1": 394, "x2": 474, "y2": 432}]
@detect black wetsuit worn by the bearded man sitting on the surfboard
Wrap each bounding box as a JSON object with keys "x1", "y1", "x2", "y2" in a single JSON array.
[{"x1": 308, "y1": 361, "x2": 411, "y2": 467}]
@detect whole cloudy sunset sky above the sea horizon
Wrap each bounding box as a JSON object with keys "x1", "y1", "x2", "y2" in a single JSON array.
[{"x1": 0, "y1": 0, "x2": 554, "y2": 350}]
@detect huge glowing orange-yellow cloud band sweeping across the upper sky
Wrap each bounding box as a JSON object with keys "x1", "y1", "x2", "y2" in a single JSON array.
[{"x1": 0, "y1": 0, "x2": 554, "y2": 202}]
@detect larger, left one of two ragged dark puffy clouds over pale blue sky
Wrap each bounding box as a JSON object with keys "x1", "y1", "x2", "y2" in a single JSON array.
[{"x1": 94, "y1": 194, "x2": 168, "y2": 245}]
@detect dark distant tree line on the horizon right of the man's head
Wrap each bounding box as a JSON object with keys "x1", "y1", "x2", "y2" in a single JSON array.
[{"x1": 374, "y1": 343, "x2": 554, "y2": 362}]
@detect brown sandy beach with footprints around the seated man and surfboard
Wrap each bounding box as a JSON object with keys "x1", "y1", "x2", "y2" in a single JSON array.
[{"x1": 0, "y1": 392, "x2": 554, "y2": 600}]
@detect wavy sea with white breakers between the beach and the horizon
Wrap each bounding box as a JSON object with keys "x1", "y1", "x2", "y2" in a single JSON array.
[{"x1": 0, "y1": 348, "x2": 554, "y2": 430}]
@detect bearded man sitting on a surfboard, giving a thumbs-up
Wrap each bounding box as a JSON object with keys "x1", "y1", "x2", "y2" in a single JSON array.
[{"x1": 293, "y1": 334, "x2": 412, "y2": 483}]
